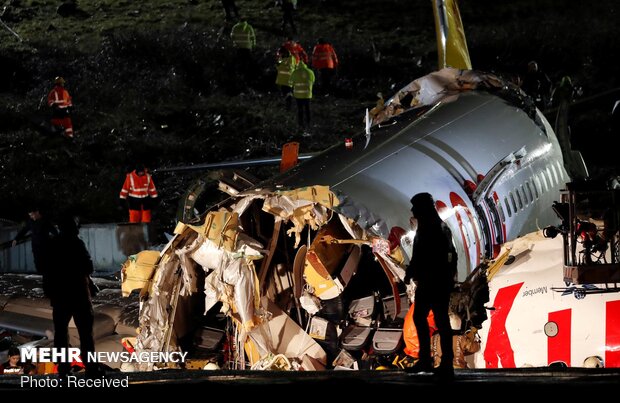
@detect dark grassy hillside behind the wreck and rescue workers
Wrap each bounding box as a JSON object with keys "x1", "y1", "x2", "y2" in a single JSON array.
[{"x1": 0, "y1": 0, "x2": 619, "y2": 237}]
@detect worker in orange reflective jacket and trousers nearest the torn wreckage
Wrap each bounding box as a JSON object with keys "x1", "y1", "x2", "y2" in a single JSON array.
[{"x1": 119, "y1": 165, "x2": 157, "y2": 223}]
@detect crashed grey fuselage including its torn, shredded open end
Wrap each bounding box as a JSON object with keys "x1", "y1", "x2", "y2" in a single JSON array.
[{"x1": 123, "y1": 68, "x2": 580, "y2": 370}]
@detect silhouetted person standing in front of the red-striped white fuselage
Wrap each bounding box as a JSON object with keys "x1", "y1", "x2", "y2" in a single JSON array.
[{"x1": 405, "y1": 193, "x2": 457, "y2": 378}]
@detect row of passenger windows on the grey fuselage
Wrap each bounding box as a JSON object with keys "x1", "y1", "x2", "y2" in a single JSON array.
[{"x1": 497, "y1": 161, "x2": 565, "y2": 221}]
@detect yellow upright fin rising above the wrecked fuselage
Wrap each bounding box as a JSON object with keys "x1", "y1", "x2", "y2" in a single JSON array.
[{"x1": 432, "y1": 0, "x2": 471, "y2": 70}]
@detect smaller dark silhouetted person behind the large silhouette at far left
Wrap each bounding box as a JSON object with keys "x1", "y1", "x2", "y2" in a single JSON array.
[{"x1": 12, "y1": 206, "x2": 58, "y2": 274}]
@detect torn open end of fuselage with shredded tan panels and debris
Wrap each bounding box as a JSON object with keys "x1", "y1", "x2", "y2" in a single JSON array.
[{"x1": 123, "y1": 186, "x2": 418, "y2": 370}]
